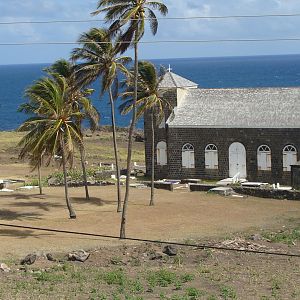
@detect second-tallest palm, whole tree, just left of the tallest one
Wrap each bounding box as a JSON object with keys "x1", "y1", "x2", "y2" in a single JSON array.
[{"x1": 72, "y1": 28, "x2": 131, "y2": 212}]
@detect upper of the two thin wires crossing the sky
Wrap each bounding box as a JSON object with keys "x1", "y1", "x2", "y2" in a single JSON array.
[{"x1": 0, "y1": 13, "x2": 300, "y2": 25}]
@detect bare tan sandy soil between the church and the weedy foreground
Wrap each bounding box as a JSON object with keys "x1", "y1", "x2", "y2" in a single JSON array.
[{"x1": 0, "y1": 187, "x2": 300, "y2": 259}]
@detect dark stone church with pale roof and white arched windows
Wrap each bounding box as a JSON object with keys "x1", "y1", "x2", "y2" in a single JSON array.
[{"x1": 144, "y1": 70, "x2": 300, "y2": 185}]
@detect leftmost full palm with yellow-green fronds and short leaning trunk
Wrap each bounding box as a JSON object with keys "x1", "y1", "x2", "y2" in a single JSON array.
[{"x1": 19, "y1": 74, "x2": 83, "y2": 219}]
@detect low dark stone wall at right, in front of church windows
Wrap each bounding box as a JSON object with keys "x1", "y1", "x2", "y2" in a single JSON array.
[{"x1": 233, "y1": 187, "x2": 300, "y2": 200}]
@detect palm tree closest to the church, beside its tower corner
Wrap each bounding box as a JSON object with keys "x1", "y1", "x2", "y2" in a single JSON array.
[{"x1": 120, "y1": 61, "x2": 171, "y2": 206}]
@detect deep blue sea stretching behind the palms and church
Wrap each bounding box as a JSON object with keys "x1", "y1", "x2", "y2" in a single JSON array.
[{"x1": 0, "y1": 55, "x2": 300, "y2": 130}]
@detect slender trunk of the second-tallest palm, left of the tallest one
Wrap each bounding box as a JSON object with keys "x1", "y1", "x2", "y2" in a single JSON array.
[{"x1": 109, "y1": 87, "x2": 122, "y2": 212}]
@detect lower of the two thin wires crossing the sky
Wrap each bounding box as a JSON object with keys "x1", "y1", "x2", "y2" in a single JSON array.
[{"x1": 0, "y1": 37, "x2": 300, "y2": 46}]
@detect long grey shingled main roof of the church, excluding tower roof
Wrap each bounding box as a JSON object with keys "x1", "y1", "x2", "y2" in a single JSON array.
[{"x1": 167, "y1": 88, "x2": 300, "y2": 128}]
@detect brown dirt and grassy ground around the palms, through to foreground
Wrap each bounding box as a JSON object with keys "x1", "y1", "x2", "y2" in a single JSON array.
[{"x1": 0, "y1": 132, "x2": 300, "y2": 300}]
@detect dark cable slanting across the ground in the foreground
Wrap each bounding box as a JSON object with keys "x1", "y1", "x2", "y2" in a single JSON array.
[{"x1": 0, "y1": 223, "x2": 300, "y2": 258}]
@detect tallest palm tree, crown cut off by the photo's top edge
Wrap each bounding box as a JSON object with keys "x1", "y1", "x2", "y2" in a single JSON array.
[{"x1": 92, "y1": 0, "x2": 168, "y2": 238}]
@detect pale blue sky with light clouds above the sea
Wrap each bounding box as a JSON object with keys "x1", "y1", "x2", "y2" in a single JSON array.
[{"x1": 0, "y1": 0, "x2": 300, "y2": 65}]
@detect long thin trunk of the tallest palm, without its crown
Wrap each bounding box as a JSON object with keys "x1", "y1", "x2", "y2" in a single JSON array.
[{"x1": 120, "y1": 34, "x2": 139, "y2": 239}]
